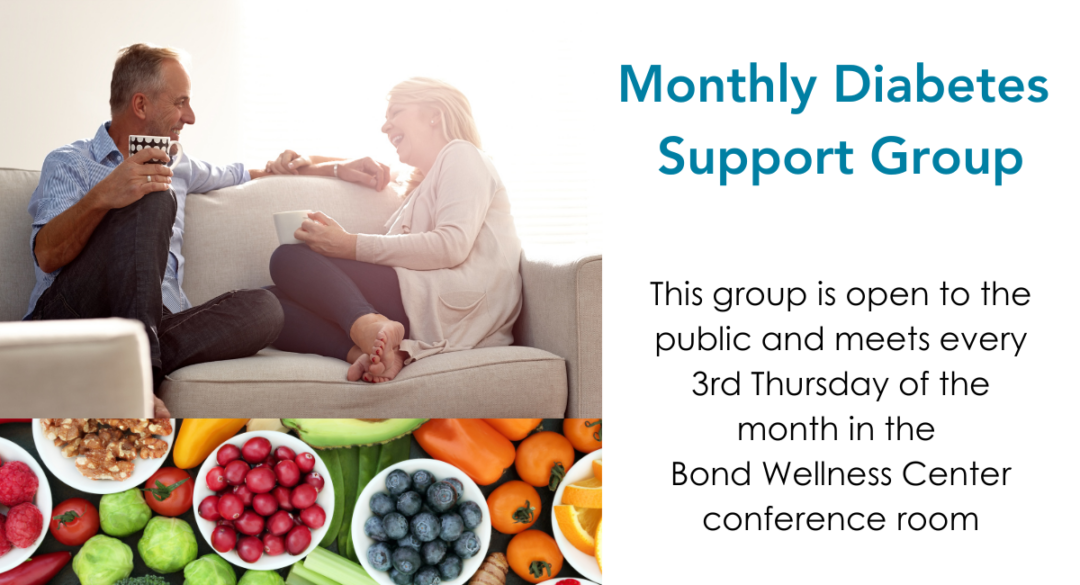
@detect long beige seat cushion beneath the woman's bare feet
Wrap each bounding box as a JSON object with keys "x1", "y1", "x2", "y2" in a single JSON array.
[{"x1": 159, "y1": 346, "x2": 567, "y2": 418}]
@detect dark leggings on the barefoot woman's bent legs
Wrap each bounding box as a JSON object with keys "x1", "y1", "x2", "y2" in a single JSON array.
[{"x1": 268, "y1": 244, "x2": 408, "y2": 359}]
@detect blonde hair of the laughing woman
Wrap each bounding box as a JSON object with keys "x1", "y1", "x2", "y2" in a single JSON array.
[{"x1": 387, "y1": 78, "x2": 483, "y2": 195}]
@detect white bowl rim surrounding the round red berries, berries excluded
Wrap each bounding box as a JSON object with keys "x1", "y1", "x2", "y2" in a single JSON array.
[{"x1": 191, "y1": 431, "x2": 335, "y2": 571}]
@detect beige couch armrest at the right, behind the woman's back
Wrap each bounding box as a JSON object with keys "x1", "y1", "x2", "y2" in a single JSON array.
[{"x1": 514, "y1": 254, "x2": 603, "y2": 418}]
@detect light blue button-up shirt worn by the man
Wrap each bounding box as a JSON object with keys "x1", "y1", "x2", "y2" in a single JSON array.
[{"x1": 23, "y1": 122, "x2": 252, "y2": 318}]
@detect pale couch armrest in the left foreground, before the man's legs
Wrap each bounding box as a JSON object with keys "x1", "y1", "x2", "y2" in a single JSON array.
[{"x1": 0, "y1": 318, "x2": 153, "y2": 419}]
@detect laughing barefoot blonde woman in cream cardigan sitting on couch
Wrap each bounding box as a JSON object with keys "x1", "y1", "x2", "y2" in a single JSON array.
[{"x1": 268, "y1": 78, "x2": 522, "y2": 382}]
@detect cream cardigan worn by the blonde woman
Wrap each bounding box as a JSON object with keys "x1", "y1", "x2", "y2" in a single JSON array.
[{"x1": 356, "y1": 140, "x2": 522, "y2": 364}]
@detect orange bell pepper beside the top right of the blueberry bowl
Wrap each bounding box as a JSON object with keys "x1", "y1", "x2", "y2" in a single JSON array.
[{"x1": 413, "y1": 419, "x2": 515, "y2": 486}]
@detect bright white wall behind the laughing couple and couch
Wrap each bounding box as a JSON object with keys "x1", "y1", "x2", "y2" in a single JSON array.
[{"x1": 0, "y1": 0, "x2": 600, "y2": 250}]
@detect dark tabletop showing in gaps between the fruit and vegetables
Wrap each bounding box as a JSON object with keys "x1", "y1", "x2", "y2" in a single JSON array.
[{"x1": 0, "y1": 419, "x2": 583, "y2": 585}]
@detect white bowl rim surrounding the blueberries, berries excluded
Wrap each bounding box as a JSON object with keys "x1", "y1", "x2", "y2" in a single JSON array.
[{"x1": 351, "y1": 459, "x2": 491, "y2": 585}]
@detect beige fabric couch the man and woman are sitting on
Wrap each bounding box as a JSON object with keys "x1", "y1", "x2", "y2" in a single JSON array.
[{"x1": 0, "y1": 169, "x2": 602, "y2": 418}]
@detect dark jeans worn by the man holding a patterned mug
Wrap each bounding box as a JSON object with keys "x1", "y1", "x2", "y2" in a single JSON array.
[{"x1": 30, "y1": 191, "x2": 283, "y2": 386}]
